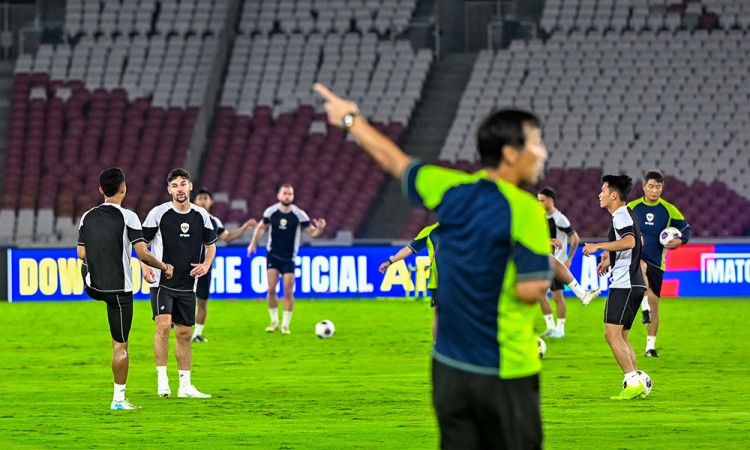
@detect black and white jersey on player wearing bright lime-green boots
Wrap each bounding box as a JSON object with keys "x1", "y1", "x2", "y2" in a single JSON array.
[{"x1": 607, "y1": 205, "x2": 646, "y2": 289}]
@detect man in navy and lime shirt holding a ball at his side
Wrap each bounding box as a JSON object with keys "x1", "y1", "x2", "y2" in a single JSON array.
[{"x1": 628, "y1": 170, "x2": 691, "y2": 357}]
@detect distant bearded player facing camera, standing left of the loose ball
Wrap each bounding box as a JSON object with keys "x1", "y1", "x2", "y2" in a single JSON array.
[{"x1": 247, "y1": 184, "x2": 326, "y2": 334}]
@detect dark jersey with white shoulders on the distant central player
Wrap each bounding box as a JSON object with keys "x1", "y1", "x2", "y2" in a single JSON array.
[{"x1": 263, "y1": 203, "x2": 310, "y2": 259}]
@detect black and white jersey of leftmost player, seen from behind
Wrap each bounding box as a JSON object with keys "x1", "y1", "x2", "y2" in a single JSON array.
[{"x1": 78, "y1": 203, "x2": 144, "y2": 294}]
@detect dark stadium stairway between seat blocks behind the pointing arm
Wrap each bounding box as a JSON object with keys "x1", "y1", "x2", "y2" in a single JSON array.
[{"x1": 364, "y1": 53, "x2": 477, "y2": 239}]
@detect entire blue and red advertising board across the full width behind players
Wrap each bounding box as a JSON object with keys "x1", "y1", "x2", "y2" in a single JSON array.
[{"x1": 7, "y1": 244, "x2": 750, "y2": 302}]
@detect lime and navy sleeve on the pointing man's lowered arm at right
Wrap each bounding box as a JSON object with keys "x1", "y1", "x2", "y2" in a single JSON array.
[{"x1": 503, "y1": 189, "x2": 552, "y2": 281}]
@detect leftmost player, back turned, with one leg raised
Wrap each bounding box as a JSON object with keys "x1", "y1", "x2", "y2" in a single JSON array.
[{"x1": 77, "y1": 167, "x2": 174, "y2": 410}]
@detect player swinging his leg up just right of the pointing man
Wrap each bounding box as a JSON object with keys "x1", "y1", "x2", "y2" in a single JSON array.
[{"x1": 537, "y1": 187, "x2": 601, "y2": 338}]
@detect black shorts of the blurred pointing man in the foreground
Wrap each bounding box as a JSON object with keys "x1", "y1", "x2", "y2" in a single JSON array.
[{"x1": 432, "y1": 359, "x2": 542, "y2": 450}]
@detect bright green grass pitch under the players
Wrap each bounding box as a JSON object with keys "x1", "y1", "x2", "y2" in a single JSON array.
[{"x1": 0, "y1": 299, "x2": 750, "y2": 449}]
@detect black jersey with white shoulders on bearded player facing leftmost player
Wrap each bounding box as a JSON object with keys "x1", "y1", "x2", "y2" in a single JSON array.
[{"x1": 143, "y1": 202, "x2": 216, "y2": 291}]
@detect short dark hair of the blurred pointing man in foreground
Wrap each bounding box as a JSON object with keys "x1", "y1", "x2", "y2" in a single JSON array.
[{"x1": 477, "y1": 109, "x2": 541, "y2": 167}]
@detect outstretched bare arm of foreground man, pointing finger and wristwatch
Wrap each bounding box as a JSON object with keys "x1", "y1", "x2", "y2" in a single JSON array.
[{"x1": 314, "y1": 83, "x2": 411, "y2": 178}]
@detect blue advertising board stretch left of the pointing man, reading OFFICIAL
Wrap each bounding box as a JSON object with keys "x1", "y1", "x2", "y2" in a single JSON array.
[{"x1": 8, "y1": 247, "x2": 430, "y2": 302}]
